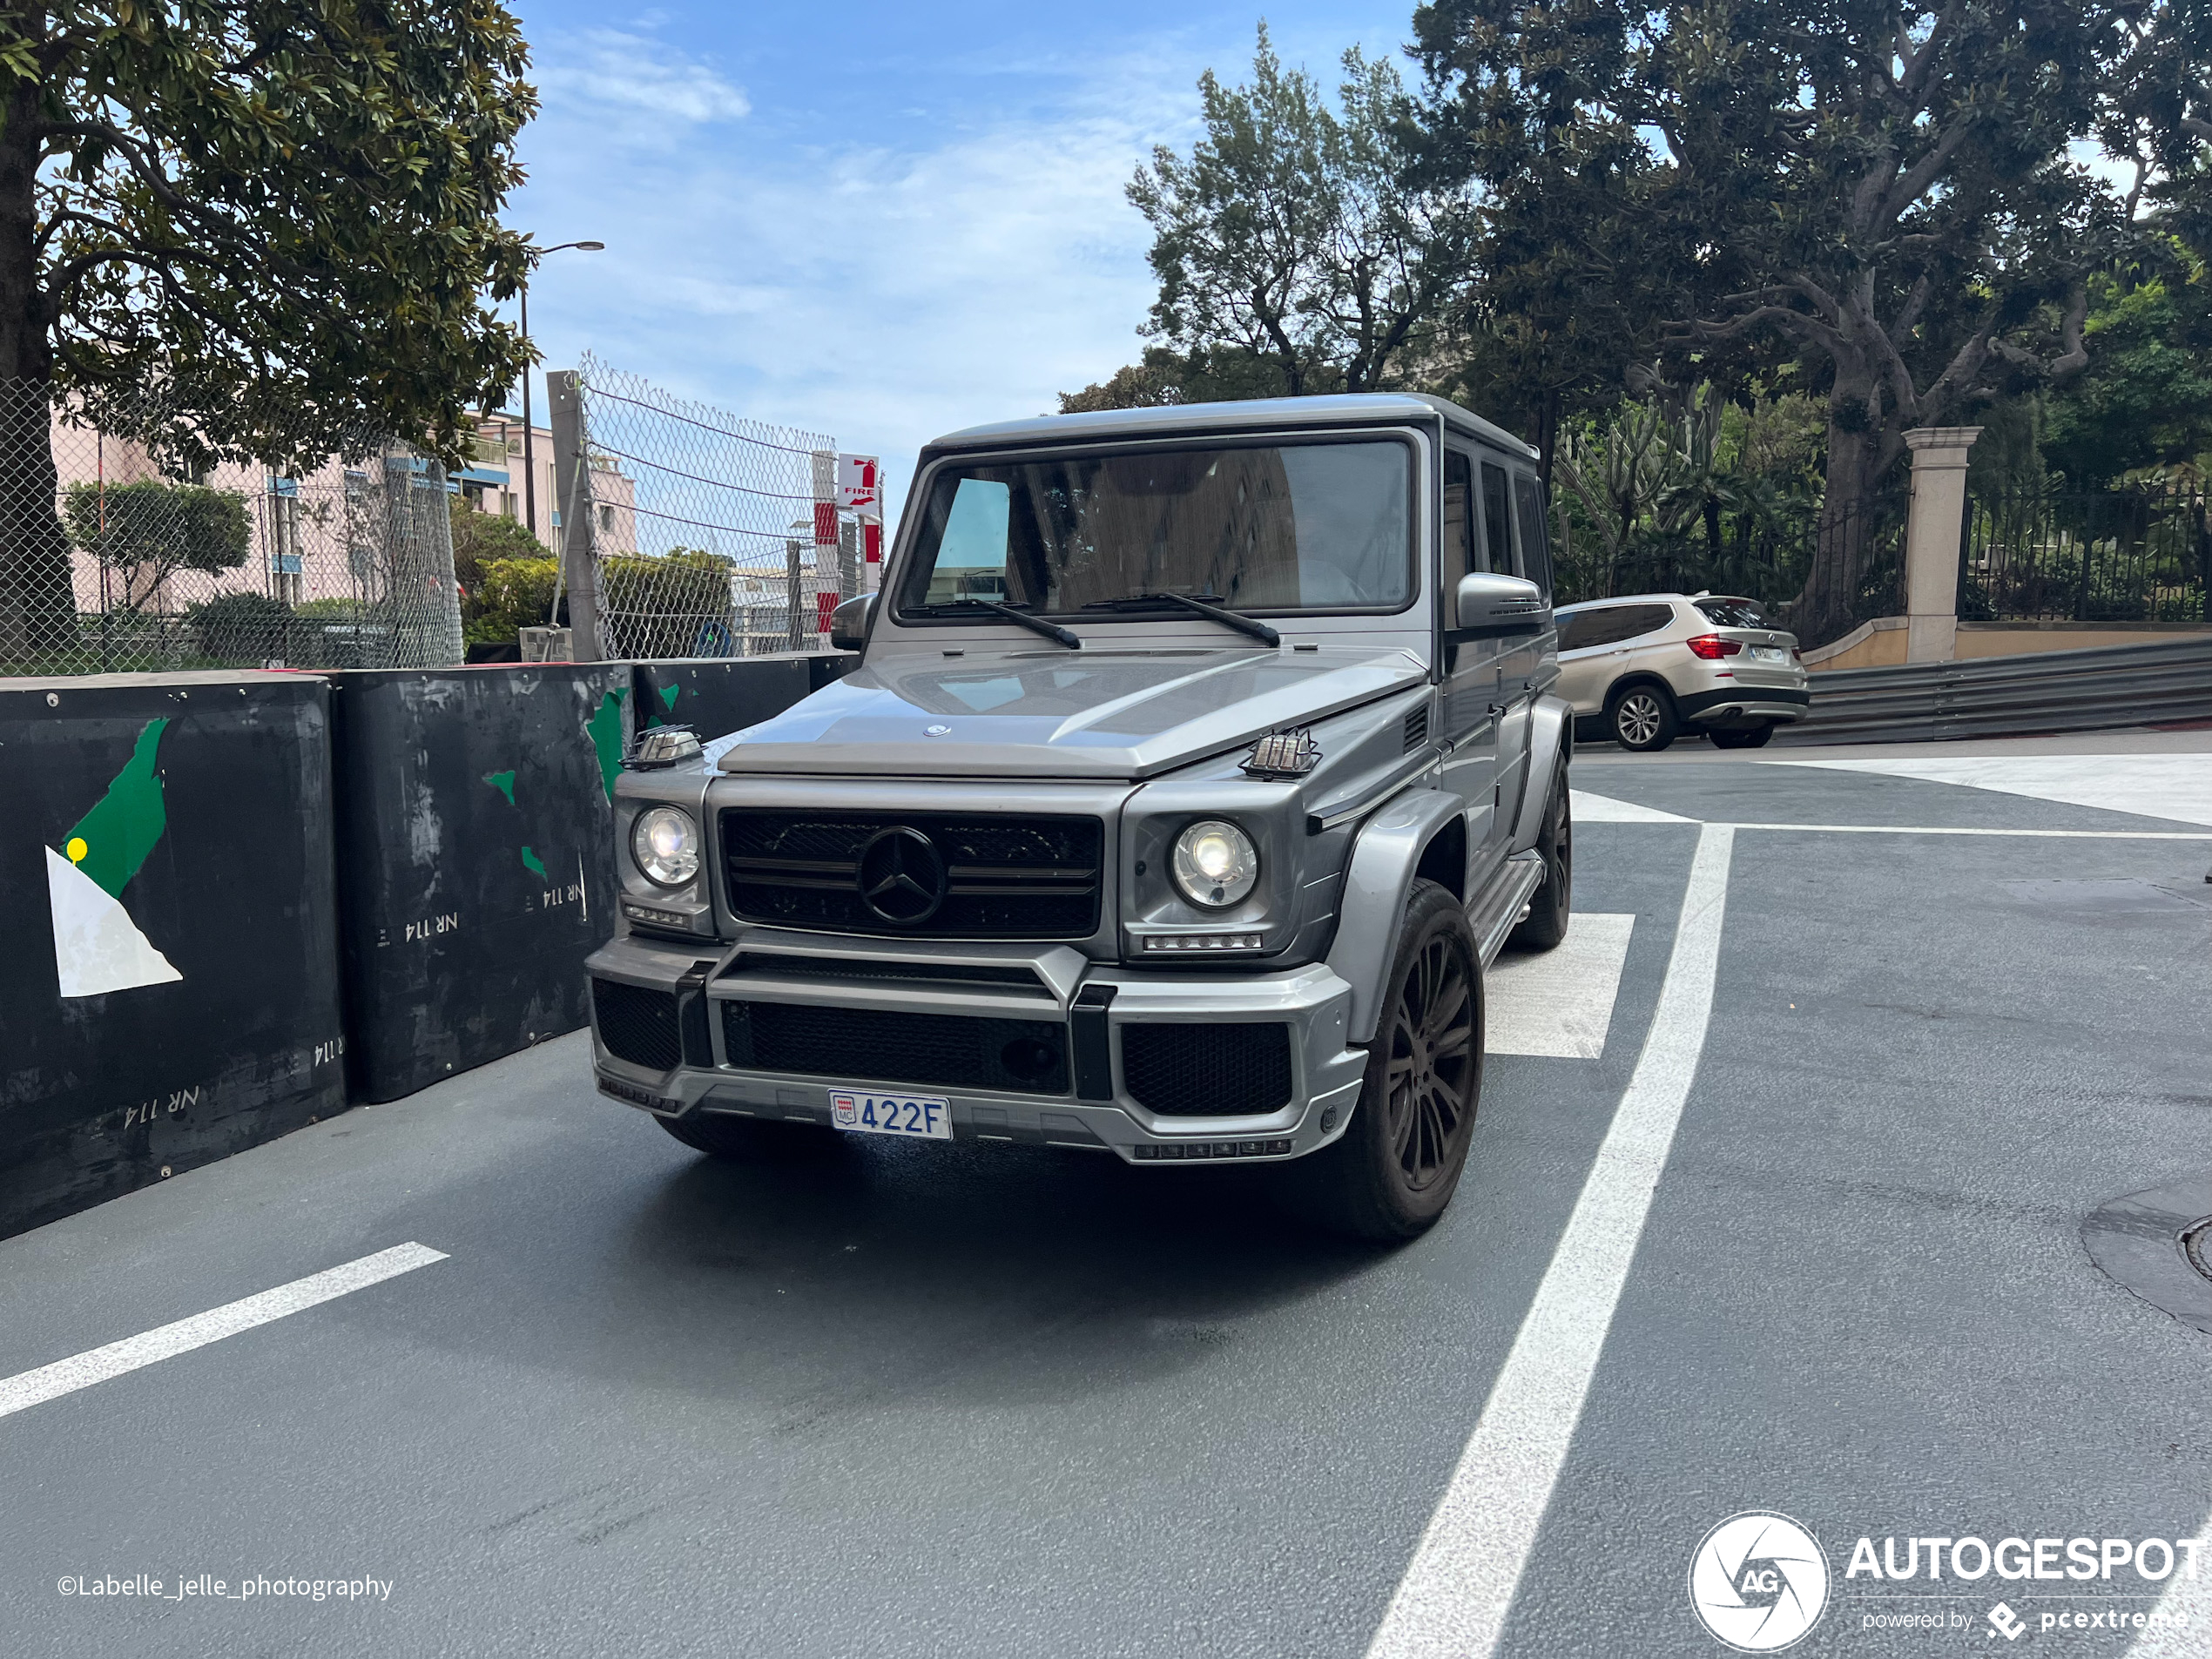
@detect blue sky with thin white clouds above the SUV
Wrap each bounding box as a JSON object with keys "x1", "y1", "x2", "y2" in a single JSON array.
[{"x1": 509, "y1": 0, "x2": 1413, "y2": 517}]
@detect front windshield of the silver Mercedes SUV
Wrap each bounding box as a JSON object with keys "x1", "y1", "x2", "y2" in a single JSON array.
[{"x1": 900, "y1": 440, "x2": 1413, "y2": 615}]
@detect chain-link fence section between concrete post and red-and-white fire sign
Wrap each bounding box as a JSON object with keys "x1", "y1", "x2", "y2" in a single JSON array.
[{"x1": 562, "y1": 354, "x2": 856, "y2": 657}]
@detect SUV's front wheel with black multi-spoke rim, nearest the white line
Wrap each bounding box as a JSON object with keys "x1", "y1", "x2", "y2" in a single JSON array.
[{"x1": 1291, "y1": 880, "x2": 1482, "y2": 1243}]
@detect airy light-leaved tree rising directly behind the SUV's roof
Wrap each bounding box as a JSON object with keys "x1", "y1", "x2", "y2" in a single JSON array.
[{"x1": 1128, "y1": 24, "x2": 1475, "y2": 396}]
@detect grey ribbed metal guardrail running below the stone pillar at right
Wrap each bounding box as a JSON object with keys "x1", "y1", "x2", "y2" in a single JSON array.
[{"x1": 1787, "y1": 632, "x2": 2212, "y2": 743}]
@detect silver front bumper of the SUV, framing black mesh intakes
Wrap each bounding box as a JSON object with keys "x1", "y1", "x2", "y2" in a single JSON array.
[{"x1": 586, "y1": 929, "x2": 1367, "y2": 1163}]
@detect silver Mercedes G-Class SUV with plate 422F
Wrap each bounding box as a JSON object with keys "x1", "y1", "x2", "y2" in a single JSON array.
[{"x1": 589, "y1": 394, "x2": 1573, "y2": 1238}]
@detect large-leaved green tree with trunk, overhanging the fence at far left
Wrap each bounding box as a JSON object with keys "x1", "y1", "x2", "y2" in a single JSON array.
[{"x1": 0, "y1": 0, "x2": 536, "y2": 659}]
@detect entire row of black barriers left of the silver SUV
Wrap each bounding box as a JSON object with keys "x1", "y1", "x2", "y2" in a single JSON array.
[{"x1": 0, "y1": 655, "x2": 852, "y2": 1234}]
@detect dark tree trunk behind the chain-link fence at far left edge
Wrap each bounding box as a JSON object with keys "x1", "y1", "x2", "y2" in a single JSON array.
[{"x1": 0, "y1": 79, "x2": 78, "y2": 672}]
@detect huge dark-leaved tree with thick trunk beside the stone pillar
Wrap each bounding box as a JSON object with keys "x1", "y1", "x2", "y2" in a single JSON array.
[{"x1": 1416, "y1": 0, "x2": 2161, "y2": 628}]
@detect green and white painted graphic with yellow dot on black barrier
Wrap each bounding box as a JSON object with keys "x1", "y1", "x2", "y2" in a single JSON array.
[{"x1": 46, "y1": 719, "x2": 184, "y2": 998}]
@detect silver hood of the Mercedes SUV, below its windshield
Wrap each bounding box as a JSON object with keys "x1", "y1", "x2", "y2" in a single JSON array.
[{"x1": 721, "y1": 648, "x2": 1426, "y2": 783}]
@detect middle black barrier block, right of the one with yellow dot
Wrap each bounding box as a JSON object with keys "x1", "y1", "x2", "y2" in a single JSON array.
[{"x1": 332, "y1": 661, "x2": 635, "y2": 1102}]
